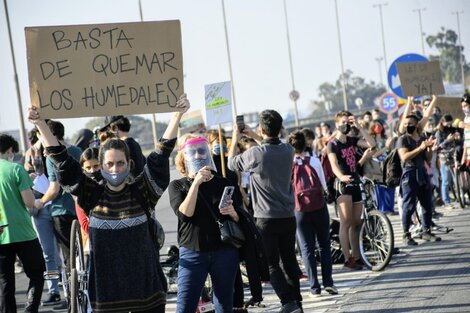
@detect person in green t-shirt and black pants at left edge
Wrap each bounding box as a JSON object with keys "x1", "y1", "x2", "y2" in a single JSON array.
[{"x1": 0, "y1": 134, "x2": 46, "y2": 313}]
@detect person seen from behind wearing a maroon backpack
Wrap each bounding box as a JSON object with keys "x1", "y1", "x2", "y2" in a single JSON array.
[{"x1": 288, "y1": 131, "x2": 338, "y2": 295}]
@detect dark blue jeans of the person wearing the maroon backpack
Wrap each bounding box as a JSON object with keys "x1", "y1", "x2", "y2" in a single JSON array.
[{"x1": 295, "y1": 206, "x2": 333, "y2": 292}]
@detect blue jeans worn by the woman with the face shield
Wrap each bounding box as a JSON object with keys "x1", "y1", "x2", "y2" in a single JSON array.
[{"x1": 176, "y1": 246, "x2": 239, "y2": 313}]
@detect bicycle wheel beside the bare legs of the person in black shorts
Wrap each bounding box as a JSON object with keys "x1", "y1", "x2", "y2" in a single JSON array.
[{"x1": 359, "y1": 210, "x2": 394, "y2": 271}]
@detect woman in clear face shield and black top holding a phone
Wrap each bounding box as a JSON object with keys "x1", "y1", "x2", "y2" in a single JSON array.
[{"x1": 168, "y1": 135, "x2": 241, "y2": 313}]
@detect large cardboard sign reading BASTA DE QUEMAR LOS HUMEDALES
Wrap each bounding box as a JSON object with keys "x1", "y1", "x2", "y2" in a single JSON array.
[{"x1": 25, "y1": 21, "x2": 184, "y2": 118}]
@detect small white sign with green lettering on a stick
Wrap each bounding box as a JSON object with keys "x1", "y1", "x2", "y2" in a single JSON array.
[{"x1": 205, "y1": 81, "x2": 233, "y2": 126}]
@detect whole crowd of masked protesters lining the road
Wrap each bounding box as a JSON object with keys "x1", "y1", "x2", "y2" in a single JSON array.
[{"x1": 0, "y1": 94, "x2": 470, "y2": 313}]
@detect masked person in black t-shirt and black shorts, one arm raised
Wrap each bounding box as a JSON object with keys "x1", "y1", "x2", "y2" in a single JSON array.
[{"x1": 327, "y1": 111, "x2": 375, "y2": 269}]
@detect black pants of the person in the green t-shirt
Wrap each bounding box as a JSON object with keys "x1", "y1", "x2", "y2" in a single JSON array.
[{"x1": 0, "y1": 239, "x2": 46, "y2": 313}]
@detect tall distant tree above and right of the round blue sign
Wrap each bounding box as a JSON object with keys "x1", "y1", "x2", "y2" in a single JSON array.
[{"x1": 426, "y1": 27, "x2": 470, "y2": 84}]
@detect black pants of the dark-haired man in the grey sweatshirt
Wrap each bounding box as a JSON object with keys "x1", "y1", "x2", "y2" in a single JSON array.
[{"x1": 256, "y1": 217, "x2": 302, "y2": 304}]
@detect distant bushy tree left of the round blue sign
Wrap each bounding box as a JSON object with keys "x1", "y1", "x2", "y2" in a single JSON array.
[{"x1": 312, "y1": 70, "x2": 386, "y2": 116}]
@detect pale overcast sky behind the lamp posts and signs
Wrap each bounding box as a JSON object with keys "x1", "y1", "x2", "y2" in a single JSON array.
[{"x1": 0, "y1": 0, "x2": 470, "y2": 136}]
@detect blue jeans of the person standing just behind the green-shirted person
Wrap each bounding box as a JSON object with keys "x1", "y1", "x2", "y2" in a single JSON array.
[{"x1": 33, "y1": 205, "x2": 60, "y2": 294}]
